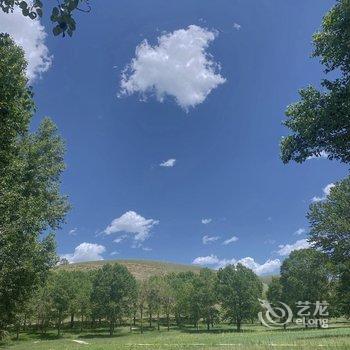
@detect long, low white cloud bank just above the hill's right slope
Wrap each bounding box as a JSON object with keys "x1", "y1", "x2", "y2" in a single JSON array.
[{"x1": 192, "y1": 255, "x2": 281, "y2": 275}]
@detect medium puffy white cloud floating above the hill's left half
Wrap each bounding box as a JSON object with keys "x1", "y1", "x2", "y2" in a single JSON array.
[{"x1": 104, "y1": 211, "x2": 159, "y2": 242}]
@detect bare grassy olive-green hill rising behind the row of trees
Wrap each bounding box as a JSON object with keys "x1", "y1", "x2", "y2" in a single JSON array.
[{"x1": 57, "y1": 259, "x2": 272, "y2": 289}]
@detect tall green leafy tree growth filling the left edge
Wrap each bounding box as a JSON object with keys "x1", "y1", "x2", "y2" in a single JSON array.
[{"x1": 0, "y1": 34, "x2": 68, "y2": 329}]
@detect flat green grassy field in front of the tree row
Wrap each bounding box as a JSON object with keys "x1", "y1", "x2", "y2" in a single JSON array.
[{"x1": 1, "y1": 323, "x2": 350, "y2": 350}]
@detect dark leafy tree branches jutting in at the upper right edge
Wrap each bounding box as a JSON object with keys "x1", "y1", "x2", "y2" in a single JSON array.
[{"x1": 281, "y1": 0, "x2": 350, "y2": 163}]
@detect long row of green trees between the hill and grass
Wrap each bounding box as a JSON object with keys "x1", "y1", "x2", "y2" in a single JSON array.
[{"x1": 14, "y1": 248, "x2": 350, "y2": 335}]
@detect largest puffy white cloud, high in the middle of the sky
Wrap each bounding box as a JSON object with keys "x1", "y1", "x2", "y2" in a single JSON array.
[{"x1": 121, "y1": 25, "x2": 225, "y2": 110}]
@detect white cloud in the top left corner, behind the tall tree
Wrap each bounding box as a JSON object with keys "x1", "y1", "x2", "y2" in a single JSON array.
[{"x1": 0, "y1": 9, "x2": 52, "y2": 83}]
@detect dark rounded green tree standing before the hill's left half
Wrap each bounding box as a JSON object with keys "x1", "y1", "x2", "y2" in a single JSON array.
[{"x1": 91, "y1": 264, "x2": 136, "y2": 335}]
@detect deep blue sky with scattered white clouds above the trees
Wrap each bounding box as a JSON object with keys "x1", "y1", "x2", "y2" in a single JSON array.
[{"x1": 0, "y1": 0, "x2": 347, "y2": 274}]
